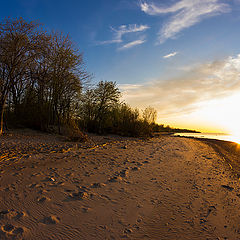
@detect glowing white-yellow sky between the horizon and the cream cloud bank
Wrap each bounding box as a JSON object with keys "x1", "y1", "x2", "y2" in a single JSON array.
[{"x1": 157, "y1": 92, "x2": 240, "y2": 136}]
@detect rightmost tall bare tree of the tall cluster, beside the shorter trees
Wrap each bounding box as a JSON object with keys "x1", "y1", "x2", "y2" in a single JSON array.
[{"x1": 45, "y1": 33, "x2": 90, "y2": 132}]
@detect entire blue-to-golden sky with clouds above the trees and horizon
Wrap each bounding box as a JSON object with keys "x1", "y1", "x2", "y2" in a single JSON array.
[{"x1": 0, "y1": 0, "x2": 240, "y2": 133}]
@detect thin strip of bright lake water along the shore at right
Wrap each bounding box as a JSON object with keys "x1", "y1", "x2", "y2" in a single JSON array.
[{"x1": 174, "y1": 133, "x2": 240, "y2": 144}]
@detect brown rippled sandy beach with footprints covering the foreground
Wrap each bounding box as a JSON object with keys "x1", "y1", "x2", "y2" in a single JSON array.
[{"x1": 0, "y1": 132, "x2": 240, "y2": 240}]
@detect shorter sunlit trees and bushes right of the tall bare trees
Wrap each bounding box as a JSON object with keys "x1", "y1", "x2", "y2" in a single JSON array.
[{"x1": 78, "y1": 81, "x2": 157, "y2": 137}]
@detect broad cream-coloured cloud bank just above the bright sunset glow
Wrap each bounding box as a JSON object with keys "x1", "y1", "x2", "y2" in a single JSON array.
[{"x1": 123, "y1": 54, "x2": 240, "y2": 117}]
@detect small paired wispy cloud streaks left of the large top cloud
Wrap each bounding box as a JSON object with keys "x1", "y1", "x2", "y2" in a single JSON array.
[{"x1": 98, "y1": 24, "x2": 150, "y2": 49}]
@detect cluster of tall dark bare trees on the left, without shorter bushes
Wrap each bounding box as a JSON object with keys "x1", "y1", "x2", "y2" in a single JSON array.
[{"x1": 0, "y1": 18, "x2": 90, "y2": 134}]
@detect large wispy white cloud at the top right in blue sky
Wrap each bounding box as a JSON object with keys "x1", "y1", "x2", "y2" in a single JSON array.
[{"x1": 140, "y1": 0, "x2": 230, "y2": 43}]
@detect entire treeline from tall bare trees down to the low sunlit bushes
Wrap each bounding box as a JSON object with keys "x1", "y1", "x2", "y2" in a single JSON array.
[{"x1": 0, "y1": 18, "x2": 160, "y2": 139}]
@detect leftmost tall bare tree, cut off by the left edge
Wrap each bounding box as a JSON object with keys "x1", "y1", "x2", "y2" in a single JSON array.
[{"x1": 0, "y1": 18, "x2": 38, "y2": 135}]
